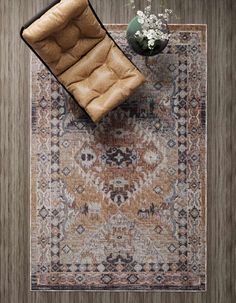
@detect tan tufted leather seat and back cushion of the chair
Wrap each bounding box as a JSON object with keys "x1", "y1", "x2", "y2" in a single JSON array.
[{"x1": 22, "y1": 0, "x2": 144, "y2": 122}]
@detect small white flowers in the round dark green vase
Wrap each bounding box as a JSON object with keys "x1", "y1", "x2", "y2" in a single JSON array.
[{"x1": 130, "y1": 0, "x2": 172, "y2": 50}]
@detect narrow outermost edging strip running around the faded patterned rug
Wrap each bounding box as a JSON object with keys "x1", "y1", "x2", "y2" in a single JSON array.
[{"x1": 29, "y1": 24, "x2": 208, "y2": 293}]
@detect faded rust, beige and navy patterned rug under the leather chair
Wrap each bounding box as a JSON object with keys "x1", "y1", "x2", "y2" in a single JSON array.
[{"x1": 31, "y1": 25, "x2": 206, "y2": 291}]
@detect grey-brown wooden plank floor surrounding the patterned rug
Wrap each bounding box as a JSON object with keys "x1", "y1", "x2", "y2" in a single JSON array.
[{"x1": 0, "y1": 0, "x2": 236, "y2": 303}]
